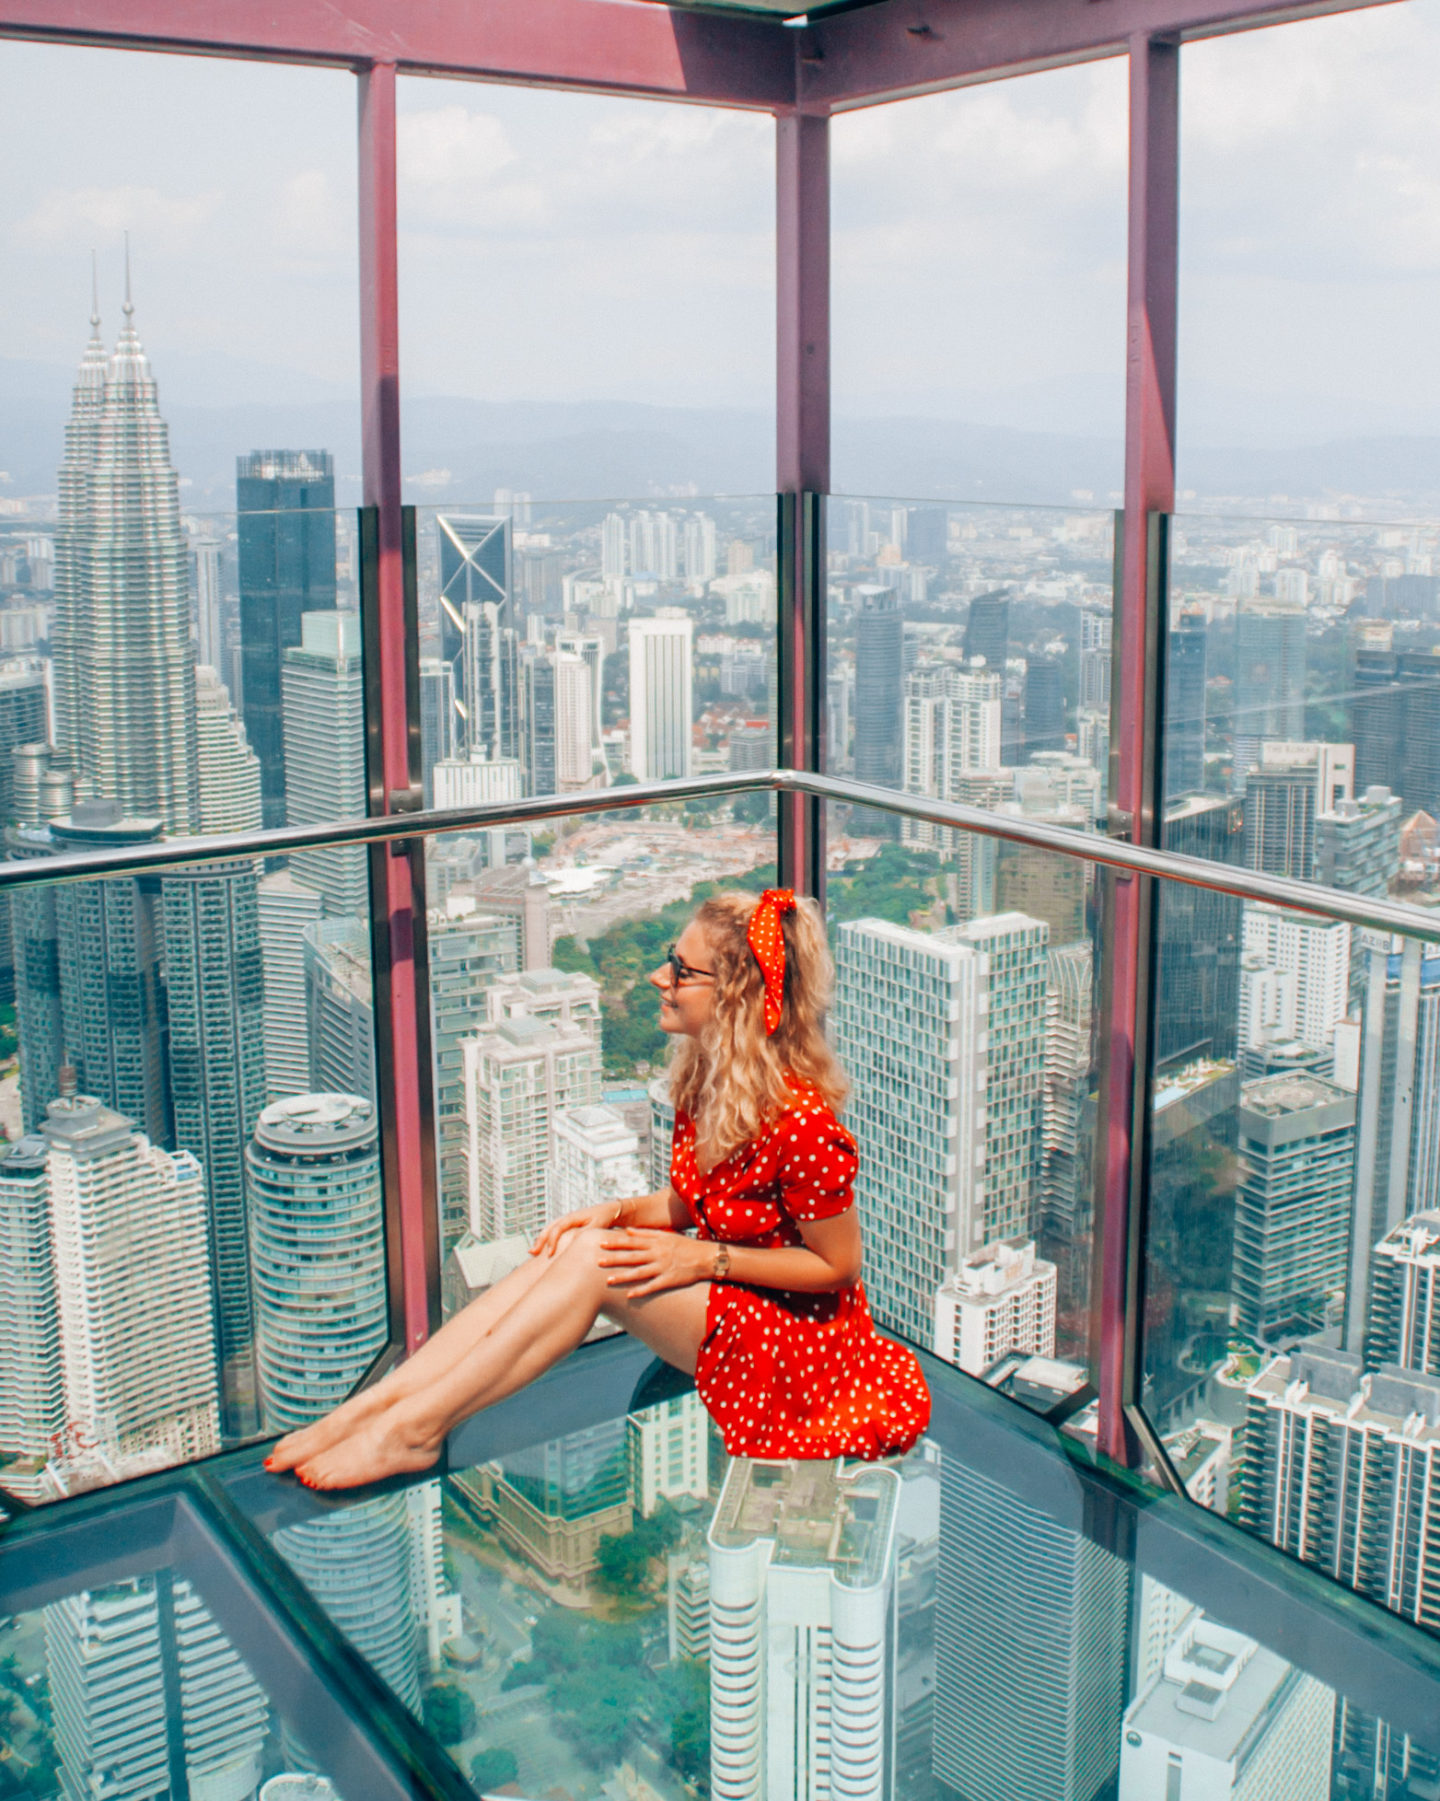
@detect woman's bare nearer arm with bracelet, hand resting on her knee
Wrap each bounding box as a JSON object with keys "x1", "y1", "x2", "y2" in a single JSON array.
[{"x1": 599, "y1": 1207, "x2": 862, "y2": 1300}]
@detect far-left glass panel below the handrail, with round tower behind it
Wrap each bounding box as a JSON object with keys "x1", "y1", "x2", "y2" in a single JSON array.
[{"x1": 0, "y1": 842, "x2": 389, "y2": 1500}]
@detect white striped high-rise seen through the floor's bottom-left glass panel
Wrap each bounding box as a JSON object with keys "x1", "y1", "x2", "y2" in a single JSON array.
[{"x1": 45, "y1": 1570, "x2": 270, "y2": 1801}]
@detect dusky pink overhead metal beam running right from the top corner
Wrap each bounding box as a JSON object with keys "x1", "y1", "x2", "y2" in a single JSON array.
[{"x1": 796, "y1": 0, "x2": 1391, "y2": 112}]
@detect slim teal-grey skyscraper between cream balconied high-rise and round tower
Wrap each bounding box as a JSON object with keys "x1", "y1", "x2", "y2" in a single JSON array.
[{"x1": 160, "y1": 859, "x2": 266, "y2": 1437}]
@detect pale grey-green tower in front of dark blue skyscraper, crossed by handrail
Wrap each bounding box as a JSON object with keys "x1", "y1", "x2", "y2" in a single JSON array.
[{"x1": 281, "y1": 611, "x2": 369, "y2": 917}]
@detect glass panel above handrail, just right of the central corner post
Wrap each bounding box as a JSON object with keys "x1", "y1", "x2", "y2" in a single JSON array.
[{"x1": 826, "y1": 497, "x2": 1114, "y2": 836}]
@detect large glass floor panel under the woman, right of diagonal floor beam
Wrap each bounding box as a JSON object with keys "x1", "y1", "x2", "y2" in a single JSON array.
[{"x1": 247, "y1": 1353, "x2": 1440, "y2": 1801}]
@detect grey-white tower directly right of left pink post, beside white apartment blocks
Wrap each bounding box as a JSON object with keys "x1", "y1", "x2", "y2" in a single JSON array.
[{"x1": 427, "y1": 895, "x2": 520, "y2": 1255}]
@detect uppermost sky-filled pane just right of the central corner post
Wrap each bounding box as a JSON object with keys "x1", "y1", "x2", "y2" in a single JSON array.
[{"x1": 830, "y1": 58, "x2": 1127, "y2": 506}]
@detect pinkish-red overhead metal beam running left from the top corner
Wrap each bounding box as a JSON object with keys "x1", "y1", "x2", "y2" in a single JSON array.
[{"x1": 0, "y1": 0, "x2": 796, "y2": 110}]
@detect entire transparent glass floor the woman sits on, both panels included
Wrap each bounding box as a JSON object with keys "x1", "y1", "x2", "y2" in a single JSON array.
[{"x1": 0, "y1": 1338, "x2": 1440, "y2": 1801}]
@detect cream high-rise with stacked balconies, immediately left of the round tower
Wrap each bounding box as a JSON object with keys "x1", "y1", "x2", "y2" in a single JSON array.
[{"x1": 43, "y1": 1093, "x2": 220, "y2": 1461}]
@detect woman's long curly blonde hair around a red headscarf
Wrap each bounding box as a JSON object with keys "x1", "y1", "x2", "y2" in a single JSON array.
[{"x1": 670, "y1": 891, "x2": 850, "y2": 1169}]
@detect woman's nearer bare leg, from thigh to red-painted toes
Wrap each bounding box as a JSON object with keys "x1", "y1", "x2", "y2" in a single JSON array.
[{"x1": 297, "y1": 1228, "x2": 709, "y2": 1488}]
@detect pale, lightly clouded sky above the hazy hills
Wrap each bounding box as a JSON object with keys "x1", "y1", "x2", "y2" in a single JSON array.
[{"x1": 0, "y1": 0, "x2": 1440, "y2": 457}]
